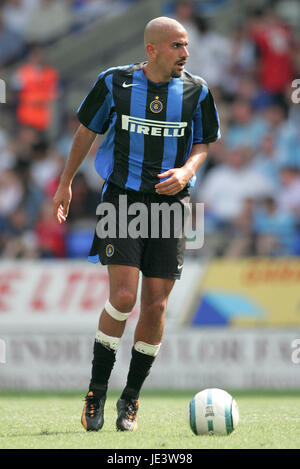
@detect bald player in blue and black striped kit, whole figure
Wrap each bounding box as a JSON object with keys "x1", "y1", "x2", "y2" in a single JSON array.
[{"x1": 53, "y1": 17, "x2": 219, "y2": 431}]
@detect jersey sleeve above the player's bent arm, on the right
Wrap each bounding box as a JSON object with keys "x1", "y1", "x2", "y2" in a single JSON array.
[{"x1": 193, "y1": 85, "x2": 221, "y2": 144}]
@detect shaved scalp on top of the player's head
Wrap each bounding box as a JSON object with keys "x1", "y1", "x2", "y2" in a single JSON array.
[{"x1": 144, "y1": 16, "x2": 186, "y2": 45}]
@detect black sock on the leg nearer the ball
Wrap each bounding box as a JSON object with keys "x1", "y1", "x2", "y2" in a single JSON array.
[{"x1": 121, "y1": 348, "x2": 155, "y2": 400}]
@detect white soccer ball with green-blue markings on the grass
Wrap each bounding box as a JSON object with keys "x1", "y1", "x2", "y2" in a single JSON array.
[{"x1": 188, "y1": 388, "x2": 239, "y2": 435}]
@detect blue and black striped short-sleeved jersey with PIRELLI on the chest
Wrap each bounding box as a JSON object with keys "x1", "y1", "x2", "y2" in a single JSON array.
[{"x1": 78, "y1": 63, "x2": 220, "y2": 192}]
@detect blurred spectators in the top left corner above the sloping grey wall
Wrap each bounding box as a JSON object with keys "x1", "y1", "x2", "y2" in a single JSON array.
[{"x1": 0, "y1": 0, "x2": 135, "y2": 70}]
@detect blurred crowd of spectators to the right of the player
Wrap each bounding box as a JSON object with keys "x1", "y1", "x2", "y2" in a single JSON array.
[{"x1": 175, "y1": 1, "x2": 300, "y2": 257}]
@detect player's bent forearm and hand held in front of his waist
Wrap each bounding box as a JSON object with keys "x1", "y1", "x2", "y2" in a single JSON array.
[{"x1": 155, "y1": 143, "x2": 208, "y2": 195}]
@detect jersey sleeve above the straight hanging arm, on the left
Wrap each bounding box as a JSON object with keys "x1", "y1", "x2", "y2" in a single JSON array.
[{"x1": 77, "y1": 72, "x2": 112, "y2": 134}]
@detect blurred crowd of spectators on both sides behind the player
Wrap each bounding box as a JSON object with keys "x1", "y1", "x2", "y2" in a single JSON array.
[{"x1": 0, "y1": 0, "x2": 300, "y2": 258}]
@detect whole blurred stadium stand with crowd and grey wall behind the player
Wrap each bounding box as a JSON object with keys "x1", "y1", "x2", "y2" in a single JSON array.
[{"x1": 0, "y1": 0, "x2": 300, "y2": 258}]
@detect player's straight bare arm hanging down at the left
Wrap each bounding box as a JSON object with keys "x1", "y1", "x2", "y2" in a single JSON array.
[{"x1": 53, "y1": 124, "x2": 97, "y2": 223}]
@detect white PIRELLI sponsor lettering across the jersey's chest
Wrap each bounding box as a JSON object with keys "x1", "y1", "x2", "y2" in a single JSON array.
[{"x1": 122, "y1": 114, "x2": 187, "y2": 137}]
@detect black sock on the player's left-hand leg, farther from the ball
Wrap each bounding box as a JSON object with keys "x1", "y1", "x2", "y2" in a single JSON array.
[{"x1": 89, "y1": 340, "x2": 116, "y2": 399}]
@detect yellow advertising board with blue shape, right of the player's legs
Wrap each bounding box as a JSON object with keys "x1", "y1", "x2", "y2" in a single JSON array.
[{"x1": 190, "y1": 258, "x2": 300, "y2": 327}]
